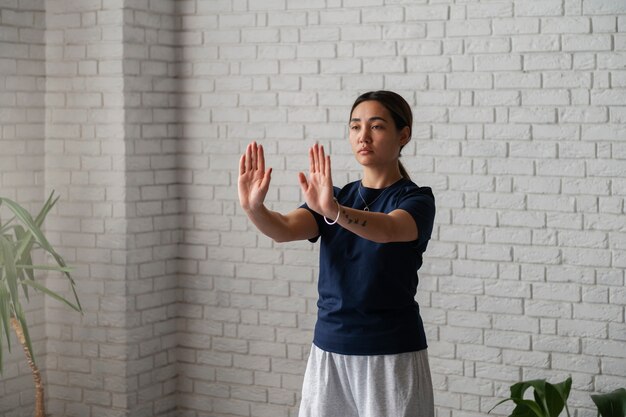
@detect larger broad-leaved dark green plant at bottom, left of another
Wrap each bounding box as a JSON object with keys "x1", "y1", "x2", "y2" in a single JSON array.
[{"x1": 489, "y1": 378, "x2": 572, "y2": 417}]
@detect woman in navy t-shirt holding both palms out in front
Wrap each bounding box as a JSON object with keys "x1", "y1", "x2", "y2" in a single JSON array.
[{"x1": 239, "y1": 91, "x2": 435, "y2": 417}]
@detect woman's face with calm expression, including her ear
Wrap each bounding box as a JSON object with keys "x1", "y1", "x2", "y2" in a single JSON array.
[{"x1": 350, "y1": 100, "x2": 410, "y2": 167}]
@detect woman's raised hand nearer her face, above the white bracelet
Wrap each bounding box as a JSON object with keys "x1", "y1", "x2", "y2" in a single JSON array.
[{"x1": 298, "y1": 143, "x2": 338, "y2": 219}]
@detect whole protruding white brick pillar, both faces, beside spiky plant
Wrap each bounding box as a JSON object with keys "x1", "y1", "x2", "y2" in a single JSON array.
[{"x1": 46, "y1": 1, "x2": 181, "y2": 416}]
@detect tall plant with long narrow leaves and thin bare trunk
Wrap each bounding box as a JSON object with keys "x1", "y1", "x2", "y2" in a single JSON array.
[{"x1": 0, "y1": 191, "x2": 82, "y2": 417}]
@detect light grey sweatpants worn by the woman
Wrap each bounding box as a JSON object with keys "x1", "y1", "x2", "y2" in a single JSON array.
[{"x1": 299, "y1": 345, "x2": 435, "y2": 417}]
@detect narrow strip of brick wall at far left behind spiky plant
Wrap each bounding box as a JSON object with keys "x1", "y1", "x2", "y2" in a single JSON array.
[{"x1": 0, "y1": 1, "x2": 46, "y2": 417}]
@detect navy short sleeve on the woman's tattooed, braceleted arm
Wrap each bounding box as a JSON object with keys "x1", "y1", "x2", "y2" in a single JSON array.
[{"x1": 397, "y1": 186, "x2": 435, "y2": 245}]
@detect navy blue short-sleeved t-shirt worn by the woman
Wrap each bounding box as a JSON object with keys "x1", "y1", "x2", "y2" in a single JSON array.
[{"x1": 302, "y1": 178, "x2": 435, "y2": 355}]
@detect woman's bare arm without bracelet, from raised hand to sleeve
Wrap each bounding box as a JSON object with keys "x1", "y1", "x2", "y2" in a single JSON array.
[{"x1": 238, "y1": 142, "x2": 318, "y2": 242}]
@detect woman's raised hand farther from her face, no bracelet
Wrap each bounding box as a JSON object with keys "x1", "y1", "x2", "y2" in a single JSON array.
[{"x1": 238, "y1": 142, "x2": 272, "y2": 211}]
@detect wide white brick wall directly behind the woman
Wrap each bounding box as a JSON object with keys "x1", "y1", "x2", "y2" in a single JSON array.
[{"x1": 179, "y1": 0, "x2": 626, "y2": 417}]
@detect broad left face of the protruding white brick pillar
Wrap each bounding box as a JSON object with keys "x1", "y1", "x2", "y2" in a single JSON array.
[{"x1": 46, "y1": 1, "x2": 127, "y2": 416}]
